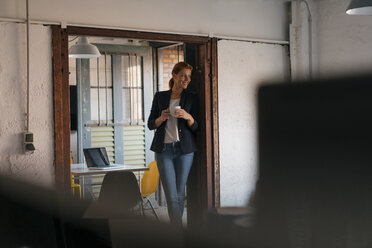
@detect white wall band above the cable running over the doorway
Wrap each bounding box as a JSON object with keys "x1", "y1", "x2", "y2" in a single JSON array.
[{"x1": 0, "y1": 0, "x2": 288, "y2": 40}]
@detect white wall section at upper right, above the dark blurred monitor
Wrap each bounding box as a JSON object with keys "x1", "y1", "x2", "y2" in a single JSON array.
[{"x1": 317, "y1": 0, "x2": 372, "y2": 76}]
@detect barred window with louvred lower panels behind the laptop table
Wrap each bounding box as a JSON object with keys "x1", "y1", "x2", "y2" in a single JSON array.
[{"x1": 70, "y1": 49, "x2": 153, "y2": 169}]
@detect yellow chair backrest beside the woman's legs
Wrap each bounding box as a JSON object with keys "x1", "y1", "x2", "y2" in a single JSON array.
[{"x1": 141, "y1": 161, "x2": 159, "y2": 197}]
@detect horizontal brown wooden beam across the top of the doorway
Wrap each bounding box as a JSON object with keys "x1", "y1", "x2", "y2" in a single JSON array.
[{"x1": 67, "y1": 27, "x2": 209, "y2": 44}]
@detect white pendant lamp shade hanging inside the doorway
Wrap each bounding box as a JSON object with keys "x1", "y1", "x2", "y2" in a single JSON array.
[{"x1": 68, "y1": 36, "x2": 101, "y2": 59}]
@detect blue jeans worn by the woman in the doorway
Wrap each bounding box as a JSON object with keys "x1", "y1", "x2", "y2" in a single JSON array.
[{"x1": 155, "y1": 143, "x2": 194, "y2": 224}]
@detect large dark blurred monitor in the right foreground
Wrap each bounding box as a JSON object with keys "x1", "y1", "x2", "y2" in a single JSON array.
[{"x1": 254, "y1": 76, "x2": 372, "y2": 248}]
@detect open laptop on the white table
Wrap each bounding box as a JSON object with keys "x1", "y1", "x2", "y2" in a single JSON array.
[{"x1": 83, "y1": 147, "x2": 124, "y2": 170}]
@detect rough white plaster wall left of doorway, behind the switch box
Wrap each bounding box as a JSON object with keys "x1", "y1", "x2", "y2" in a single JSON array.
[{"x1": 0, "y1": 22, "x2": 54, "y2": 187}]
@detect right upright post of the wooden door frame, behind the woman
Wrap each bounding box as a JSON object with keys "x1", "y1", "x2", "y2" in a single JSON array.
[{"x1": 186, "y1": 42, "x2": 215, "y2": 228}]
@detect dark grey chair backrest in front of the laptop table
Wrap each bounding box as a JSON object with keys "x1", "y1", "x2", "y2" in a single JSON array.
[{"x1": 97, "y1": 171, "x2": 142, "y2": 210}]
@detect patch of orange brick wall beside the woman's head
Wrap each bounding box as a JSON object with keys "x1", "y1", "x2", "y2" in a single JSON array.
[{"x1": 159, "y1": 45, "x2": 184, "y2": 90}]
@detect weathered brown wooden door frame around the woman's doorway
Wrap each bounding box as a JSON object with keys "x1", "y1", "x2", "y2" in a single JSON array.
[{"x1": 52, "y1": 25, "x2": 220, "y2": 223}]
